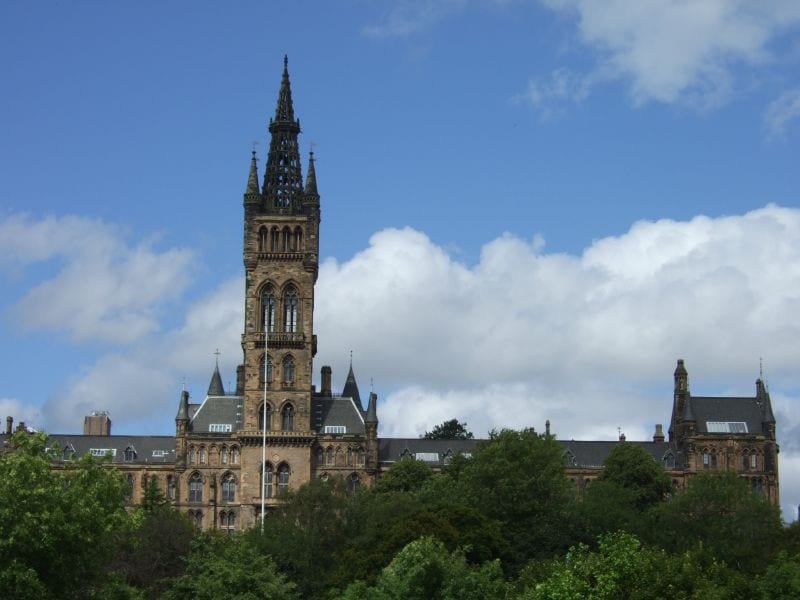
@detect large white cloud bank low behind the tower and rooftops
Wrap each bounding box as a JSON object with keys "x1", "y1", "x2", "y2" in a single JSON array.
[{"x1": 0, "y1": 205, "x2": 800, "y2": 514}]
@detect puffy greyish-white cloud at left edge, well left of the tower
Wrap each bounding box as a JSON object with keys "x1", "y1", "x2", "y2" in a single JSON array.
[{"x1": 0, "y1": 215, "x2": 193, "y2": 344}]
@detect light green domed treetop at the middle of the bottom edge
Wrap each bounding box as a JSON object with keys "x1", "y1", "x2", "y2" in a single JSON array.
[{"x1": 341, "y1": 537, "x2": 509, "y2": 600}]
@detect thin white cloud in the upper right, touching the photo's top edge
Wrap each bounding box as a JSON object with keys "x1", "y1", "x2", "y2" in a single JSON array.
[{"x1": 541, "y1": 0, "x2": 800, "y2": 109}]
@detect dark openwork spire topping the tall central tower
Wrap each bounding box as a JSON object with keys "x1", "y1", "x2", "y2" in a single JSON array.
[{"x1": 262, "y1": 56, "x2": 303, "y2": 213}]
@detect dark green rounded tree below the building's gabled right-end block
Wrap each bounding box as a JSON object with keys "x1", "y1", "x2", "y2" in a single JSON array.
[{"x1": 650, "y1": 472, "x2": 782, "y2": 573}]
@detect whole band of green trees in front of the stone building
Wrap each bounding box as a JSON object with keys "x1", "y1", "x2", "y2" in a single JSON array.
[{"x1": 0, "y1": 429, "x2": 800, "y2": 600}]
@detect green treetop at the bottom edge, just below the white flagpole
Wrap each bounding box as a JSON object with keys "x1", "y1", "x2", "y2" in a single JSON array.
[{"x1": 163, "y1": 533, "x2": 298, "y2": 600}]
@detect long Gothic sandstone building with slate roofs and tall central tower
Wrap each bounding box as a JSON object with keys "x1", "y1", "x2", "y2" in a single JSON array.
[{"x1": 0, "y1": 58, "x2": 778, "y2": 531}]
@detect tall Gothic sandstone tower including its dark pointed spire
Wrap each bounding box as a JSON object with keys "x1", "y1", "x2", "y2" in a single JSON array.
[{"x1": 239, "y1": 57, "x2": 320, "y2": 516}]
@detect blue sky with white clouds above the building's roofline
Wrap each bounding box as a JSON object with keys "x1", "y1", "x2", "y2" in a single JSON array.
[{"x1": 0, "y1": 0, "x2": 800, "y2": 520}]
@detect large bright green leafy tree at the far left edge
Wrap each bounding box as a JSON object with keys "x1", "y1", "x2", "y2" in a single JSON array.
[{"x1": 0, "y1": 433, "x2": 129, "y2": 599}]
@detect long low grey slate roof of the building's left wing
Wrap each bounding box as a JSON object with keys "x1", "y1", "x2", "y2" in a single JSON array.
[{"x1": 21, "y1": 434, "x2": 175, "y2": 465}]
